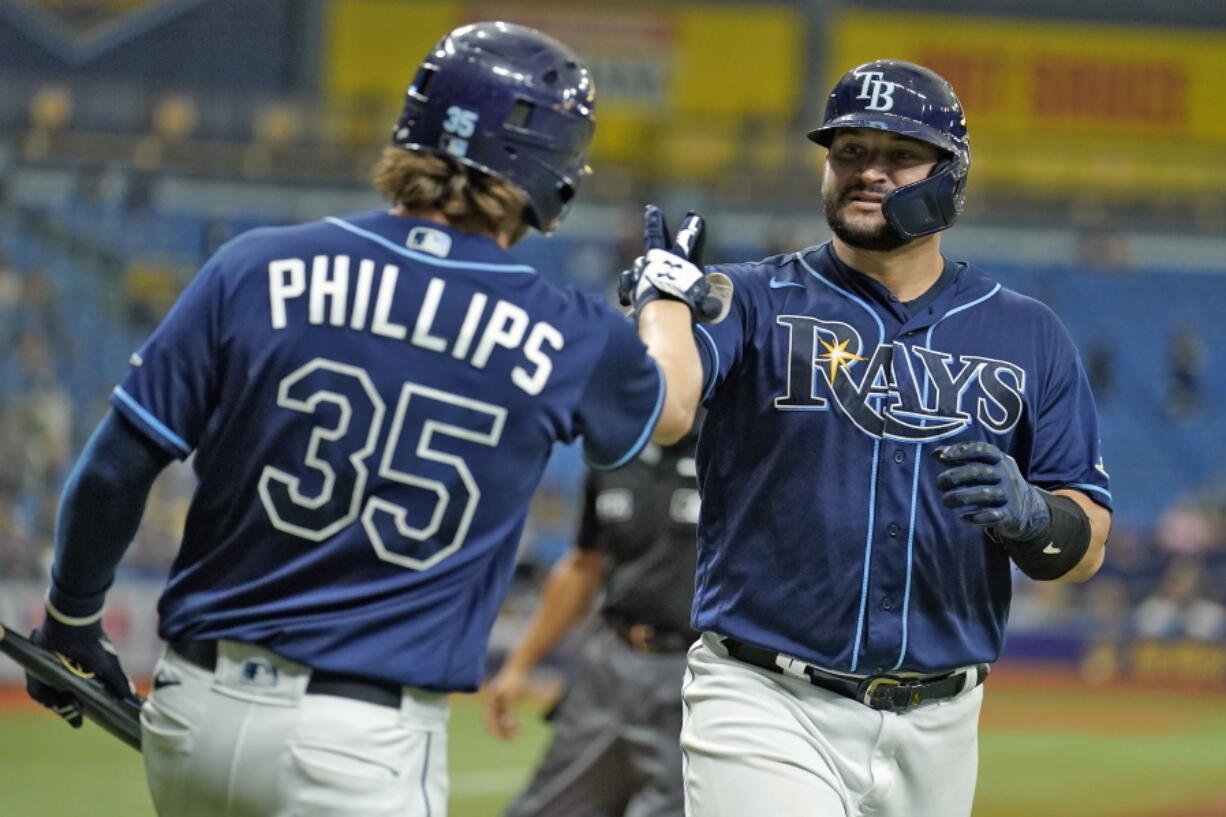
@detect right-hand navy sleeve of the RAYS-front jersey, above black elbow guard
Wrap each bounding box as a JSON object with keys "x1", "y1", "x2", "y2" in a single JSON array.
[{"x1": 1027, "y1": 315, "x2": 1112, "y2": 509}]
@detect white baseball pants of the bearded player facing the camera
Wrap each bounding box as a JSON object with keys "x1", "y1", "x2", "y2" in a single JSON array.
[{"x1": 682, "y1": 633, "x2": 983, "y2": 817}]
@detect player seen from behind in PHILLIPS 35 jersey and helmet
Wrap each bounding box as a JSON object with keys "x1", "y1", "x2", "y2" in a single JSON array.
[{"x1": 23, "y1": 23, "x2": 696, "y2": 817}]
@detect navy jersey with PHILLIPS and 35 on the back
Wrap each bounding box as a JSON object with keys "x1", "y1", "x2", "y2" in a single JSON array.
[{"x1": 110, "y1": 212, "x2": 663, "y2": 689}]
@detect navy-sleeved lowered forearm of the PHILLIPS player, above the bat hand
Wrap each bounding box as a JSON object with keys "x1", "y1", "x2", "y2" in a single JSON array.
[{"x1": 49, "y1": 413, "x2": 169, "y2": 618}]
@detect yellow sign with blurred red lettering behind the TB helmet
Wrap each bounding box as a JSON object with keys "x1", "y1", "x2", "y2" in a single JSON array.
[{"x1": 825, "y1": 10, "x2": 1226, "y2": 196}]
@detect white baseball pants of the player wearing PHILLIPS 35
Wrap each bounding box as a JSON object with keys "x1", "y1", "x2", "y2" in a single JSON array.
[{"x1": 141, "y1": 642, "x2": 449, "y2": 817}]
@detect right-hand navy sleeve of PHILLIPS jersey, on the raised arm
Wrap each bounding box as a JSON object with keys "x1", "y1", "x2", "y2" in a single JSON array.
[{"x1": 576, "y1": 304, "x2": 664, "y2": 470}]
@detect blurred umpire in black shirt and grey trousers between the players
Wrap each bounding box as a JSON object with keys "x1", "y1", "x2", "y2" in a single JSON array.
[{"x1": 484, "y1": 421, "x2": 699, "y2": 817}]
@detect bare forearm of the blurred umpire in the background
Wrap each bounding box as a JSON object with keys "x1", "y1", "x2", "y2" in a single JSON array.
[{"x1": 505, "y1": 550, "x2": 601, "y2": 672}]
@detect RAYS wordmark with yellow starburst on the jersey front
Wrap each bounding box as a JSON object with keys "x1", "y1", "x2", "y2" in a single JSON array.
[{"x1": 775, "y1": 315, "x2": 1026, "y2": 443}]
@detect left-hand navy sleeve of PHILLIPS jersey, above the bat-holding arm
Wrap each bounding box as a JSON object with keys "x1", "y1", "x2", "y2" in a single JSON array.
[{"x1": 110, "y1": 256, "x2": 222, "y2": 460}]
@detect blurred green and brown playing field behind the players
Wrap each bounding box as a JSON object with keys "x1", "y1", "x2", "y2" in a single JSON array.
[{"x1": 0, "y1": 678, "x2": 1226, "y2": 817}]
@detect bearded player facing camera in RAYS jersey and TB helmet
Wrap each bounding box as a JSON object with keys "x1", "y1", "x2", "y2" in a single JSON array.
[{"x1": 622, "y1": 60, "x2": 1111, "y2": 817}]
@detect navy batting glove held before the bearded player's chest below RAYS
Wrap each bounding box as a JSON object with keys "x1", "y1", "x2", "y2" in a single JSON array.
[{"x1": 933, "y1": 440, "x2": 1051, "y2": 542}]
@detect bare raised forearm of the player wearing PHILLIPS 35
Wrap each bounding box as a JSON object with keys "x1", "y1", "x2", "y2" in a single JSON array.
[{"x1": 639, "y1": 298, "x2": 702, "y2": 445}]
